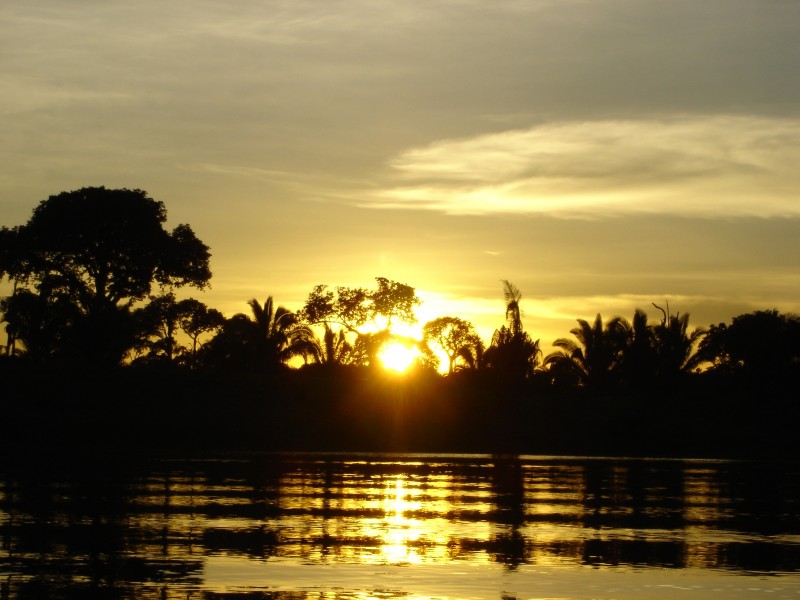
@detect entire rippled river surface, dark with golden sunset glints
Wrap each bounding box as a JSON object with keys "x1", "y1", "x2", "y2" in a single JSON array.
[{"x1": 0, "y1": 454, "x2": 800, "y2": 600}]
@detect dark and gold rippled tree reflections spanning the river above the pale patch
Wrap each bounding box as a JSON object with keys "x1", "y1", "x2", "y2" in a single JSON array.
[{"x1": 0, "y1": 455, "x2": 800, "y2": 598}]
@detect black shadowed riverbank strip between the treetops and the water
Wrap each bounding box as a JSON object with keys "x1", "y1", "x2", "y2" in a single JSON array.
[{"x1": 0, "y1": 360, "x2": 800, "y2": 458}]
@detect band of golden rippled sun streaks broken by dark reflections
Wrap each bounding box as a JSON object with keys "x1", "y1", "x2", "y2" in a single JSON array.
[{"x1": 129, "y1": 461, "x2": 796, "y2": 569}]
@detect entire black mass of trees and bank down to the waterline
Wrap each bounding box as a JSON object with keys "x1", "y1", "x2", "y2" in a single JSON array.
[{"x1": 0, "y1": 188, "x2": 800, "y2": 456}]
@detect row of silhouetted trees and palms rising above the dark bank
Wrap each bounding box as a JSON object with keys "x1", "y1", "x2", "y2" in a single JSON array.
[{"x1": 0, "y1": 187, "x2": 800, "y2": 393}]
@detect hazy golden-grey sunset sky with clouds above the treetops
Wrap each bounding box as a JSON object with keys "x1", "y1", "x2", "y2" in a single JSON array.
[{"x1": 0, "y1": 0, "x2": 800, "y2": 348}]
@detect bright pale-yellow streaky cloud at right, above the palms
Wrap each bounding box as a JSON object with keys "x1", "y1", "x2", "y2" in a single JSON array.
[{"x1": 364, "y1": 116, "x2": 800, "y2": 217}]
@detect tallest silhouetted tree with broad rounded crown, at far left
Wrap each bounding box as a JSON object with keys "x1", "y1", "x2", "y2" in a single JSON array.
[{"x1": 0, "y1": 187, "x2": 211, "y2": 364}]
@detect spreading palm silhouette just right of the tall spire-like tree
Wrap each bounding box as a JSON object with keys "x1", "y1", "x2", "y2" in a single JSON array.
[{"x1": 544, "y1": 314, "x2": 626, "y2": 389}]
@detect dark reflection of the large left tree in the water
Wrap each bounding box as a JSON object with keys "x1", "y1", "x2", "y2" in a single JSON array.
[{"x1": 0, "y1": 464, "x2": 202, "y2": 598}]
